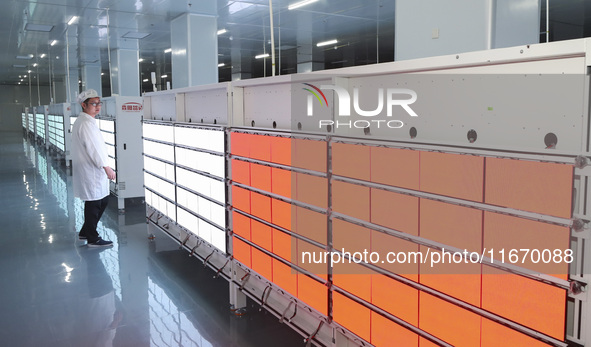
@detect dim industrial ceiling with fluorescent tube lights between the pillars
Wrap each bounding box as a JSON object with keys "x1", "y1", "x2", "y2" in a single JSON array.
[{"x1": 0, "y1": 0, "x2": 394, "y2": 90}]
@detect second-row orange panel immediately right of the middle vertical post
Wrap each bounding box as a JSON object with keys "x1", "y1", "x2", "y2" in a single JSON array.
[{"x1": 332, "y1": 181, "x2": 369, "y2": 221}]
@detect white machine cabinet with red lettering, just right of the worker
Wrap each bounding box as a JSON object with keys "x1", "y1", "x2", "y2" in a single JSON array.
[{"x1": 97, "y1": 96, "x2": 144, "y2": 212}]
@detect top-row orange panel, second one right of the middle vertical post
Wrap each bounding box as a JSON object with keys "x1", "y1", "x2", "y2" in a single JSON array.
[{"x1": 371, "y1": 147, "x2": 420, "y2": 190}]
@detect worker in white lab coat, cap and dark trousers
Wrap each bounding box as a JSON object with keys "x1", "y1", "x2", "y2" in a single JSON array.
[{"x1": 72, "y1": 89, "x2": 115, "y2": 247}]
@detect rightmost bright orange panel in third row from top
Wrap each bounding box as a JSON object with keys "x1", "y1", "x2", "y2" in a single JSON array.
[{"x1": 482, "y1": 267, "x2": 566, "y2": 340}]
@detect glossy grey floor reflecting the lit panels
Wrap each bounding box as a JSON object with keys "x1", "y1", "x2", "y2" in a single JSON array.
[{"x1": 0, "y1": 132, "x2": 304, "y2": 347}]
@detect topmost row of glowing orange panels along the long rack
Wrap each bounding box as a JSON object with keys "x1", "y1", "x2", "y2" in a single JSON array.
[{"x1": 231, "y1": 132, "x2": 573, "y2": 218}]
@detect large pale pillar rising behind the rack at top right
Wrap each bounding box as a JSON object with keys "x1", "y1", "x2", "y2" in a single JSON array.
[{"x1": 395, "y1": 0, "x2": 540, "y2": 60}]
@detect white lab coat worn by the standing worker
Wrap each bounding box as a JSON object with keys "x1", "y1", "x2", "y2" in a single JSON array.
[{"x1": 72, "y1": 112, "x2": 109, "y2": 201}]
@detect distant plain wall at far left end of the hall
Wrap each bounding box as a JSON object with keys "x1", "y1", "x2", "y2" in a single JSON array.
[{"x1": 0, "y1": 86, "x2": 49, "y2": 131}]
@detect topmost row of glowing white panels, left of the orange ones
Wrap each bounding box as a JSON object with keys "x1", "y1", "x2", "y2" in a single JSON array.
[{"x1": 143, "y1": 123, "x2": 225, "y2": 154}]
